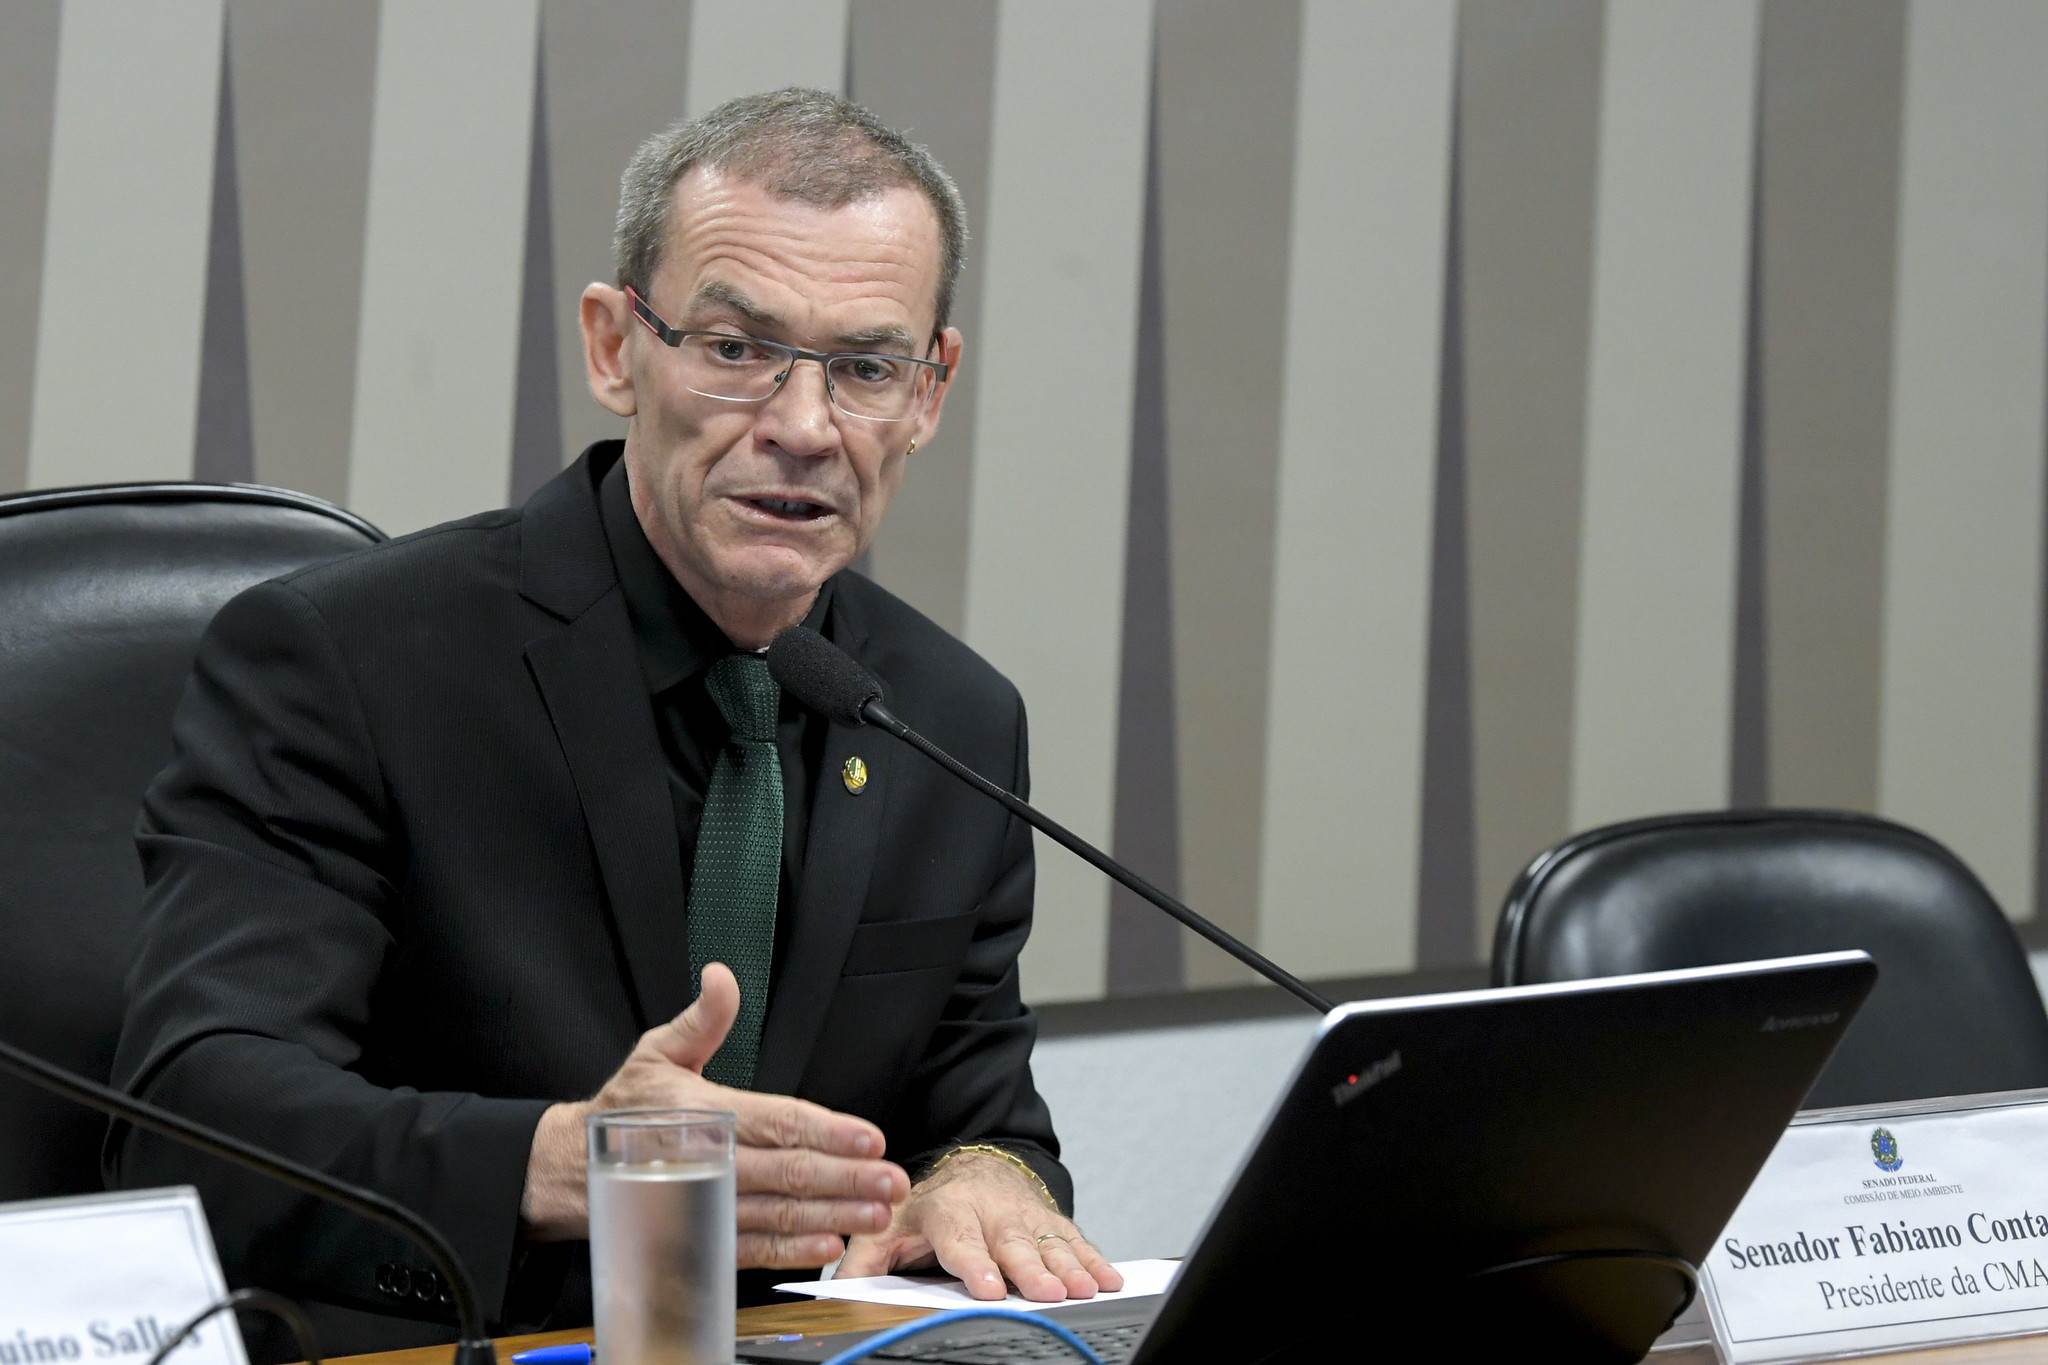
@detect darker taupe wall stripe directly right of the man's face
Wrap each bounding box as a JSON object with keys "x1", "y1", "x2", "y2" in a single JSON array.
[{"x1": 846, "y1": 0, "x2": 995, "y2": 634}]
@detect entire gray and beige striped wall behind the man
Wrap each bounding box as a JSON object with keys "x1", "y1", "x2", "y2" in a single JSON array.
[{"x1": 12, "y1": 0, "x2": 2048, "y2": 999}]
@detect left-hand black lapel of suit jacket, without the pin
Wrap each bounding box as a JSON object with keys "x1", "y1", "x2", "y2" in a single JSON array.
[{"x1": 520, "y1": 442, "x2": 692, "y2": 1027}]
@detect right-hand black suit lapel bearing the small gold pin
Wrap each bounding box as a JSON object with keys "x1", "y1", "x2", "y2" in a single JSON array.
[{"x1": 754, "y1": 618, "x2": 880, "y2": 1095}]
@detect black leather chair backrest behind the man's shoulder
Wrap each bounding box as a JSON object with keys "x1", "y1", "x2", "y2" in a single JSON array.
[{"x1": 0, "y1": 483, "x2": 383, "y2": 1201}]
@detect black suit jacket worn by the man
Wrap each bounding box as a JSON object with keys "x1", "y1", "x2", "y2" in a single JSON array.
[{"x1": 109, "y1": 442, "x2": 1071, "y2": 1326}]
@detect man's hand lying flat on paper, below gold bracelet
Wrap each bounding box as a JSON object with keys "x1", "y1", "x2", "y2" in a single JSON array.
[{"x1": 836, "y1": 1152, "x2": 1124, "y2": 1304}]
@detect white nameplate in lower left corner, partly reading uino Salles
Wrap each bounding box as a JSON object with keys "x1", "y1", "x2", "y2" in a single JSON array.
[{"x1": 0, "y1": 1187, "x2": 248, "y2": 1365}]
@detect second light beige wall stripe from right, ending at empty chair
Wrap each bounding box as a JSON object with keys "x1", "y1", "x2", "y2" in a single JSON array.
[{"x1": 1571, "y1": 0, "x2": 1757, "y2": 827}]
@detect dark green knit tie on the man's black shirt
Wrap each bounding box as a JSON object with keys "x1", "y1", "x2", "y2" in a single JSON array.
[{"x1": 690, "y1": 655, "x2": 782, "y2": 1087}]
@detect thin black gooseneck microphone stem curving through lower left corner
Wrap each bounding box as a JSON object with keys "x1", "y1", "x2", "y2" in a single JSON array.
[{"x1": 0, "y1": 1040, "x2": 498, "y2": 1365}]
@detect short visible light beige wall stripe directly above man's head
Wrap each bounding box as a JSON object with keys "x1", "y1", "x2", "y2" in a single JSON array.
[{"x1": 684, "y1": 0, "x2": 848, "y2": 119}]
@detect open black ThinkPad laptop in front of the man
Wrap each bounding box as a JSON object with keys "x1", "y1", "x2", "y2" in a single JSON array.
[{"x1": 737, "y1": 952, "x2": 1876, "y2": 1365}]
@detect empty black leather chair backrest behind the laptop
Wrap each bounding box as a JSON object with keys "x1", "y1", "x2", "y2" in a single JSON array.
[{"x1": 1493, "y1": 810, "x2": 2048, "y2": 1107}]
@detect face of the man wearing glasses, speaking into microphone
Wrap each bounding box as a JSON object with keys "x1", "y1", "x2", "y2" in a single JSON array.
[{"x1": 586, "y1": 168, "x2": 961, "y2": 630}]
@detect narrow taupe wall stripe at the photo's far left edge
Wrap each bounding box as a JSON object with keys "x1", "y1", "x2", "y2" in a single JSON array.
[{"x1": 0, "y1": 0, "x2": 57, "y2": 493}]
